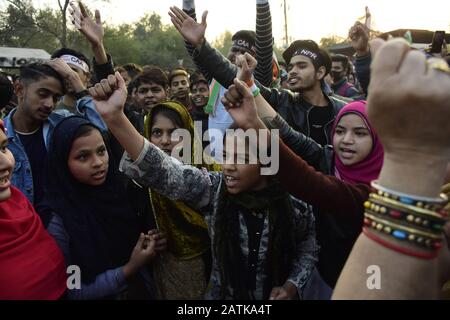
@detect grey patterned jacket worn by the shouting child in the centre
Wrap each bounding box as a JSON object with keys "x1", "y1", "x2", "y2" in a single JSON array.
[{"x1": 120, "y1": 140, "x2": 319, "y2": 299}]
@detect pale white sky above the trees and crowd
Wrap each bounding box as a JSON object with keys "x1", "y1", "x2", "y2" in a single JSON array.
[{"x1": 32, "y1": 0, "x2": 450, "y2": 45}]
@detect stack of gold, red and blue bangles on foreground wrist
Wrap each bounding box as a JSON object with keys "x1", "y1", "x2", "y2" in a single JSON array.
[{"x1": 363, "y1": 181, "x2": 449, "y2": 259}]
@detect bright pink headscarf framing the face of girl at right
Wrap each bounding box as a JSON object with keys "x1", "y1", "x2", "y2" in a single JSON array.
[{"x1": 331, "y1": 101, "x2": 384, "y2": 185}]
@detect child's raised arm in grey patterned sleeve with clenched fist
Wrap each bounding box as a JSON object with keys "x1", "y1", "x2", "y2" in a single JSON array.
[{"x1": 89, "y1": 72, "x2": 212, "y2": 208}]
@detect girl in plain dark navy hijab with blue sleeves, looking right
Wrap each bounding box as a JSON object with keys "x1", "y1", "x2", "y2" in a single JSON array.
[{"x1": 46, "y1": 116, "x2": 162, "y2": 299}]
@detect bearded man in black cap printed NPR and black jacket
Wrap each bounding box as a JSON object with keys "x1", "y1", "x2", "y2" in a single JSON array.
[{"x1": 276, "y1": 40, "x2": 344, "y2": 145}]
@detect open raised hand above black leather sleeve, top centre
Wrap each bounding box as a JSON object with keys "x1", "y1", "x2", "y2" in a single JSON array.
[{"x1": 169, "y1": 7, "x2": 208, "y2": 48}]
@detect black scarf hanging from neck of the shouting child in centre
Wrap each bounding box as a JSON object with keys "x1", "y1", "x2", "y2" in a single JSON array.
[{"x1": 213, "y1": 182, "x2": 296, "y2": 300}]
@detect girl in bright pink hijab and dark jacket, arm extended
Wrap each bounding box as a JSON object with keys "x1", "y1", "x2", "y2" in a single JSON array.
[{"x1": 270, "y1": 101, "x2": 383, "y2": 299}]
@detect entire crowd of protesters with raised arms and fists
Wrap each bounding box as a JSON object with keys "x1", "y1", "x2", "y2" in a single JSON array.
[{"x1": 0, "y1": 0, "x2": 450, "y2": 300}]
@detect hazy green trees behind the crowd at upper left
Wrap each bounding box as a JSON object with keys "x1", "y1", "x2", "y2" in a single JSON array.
[{"x1": 0, "y1": 0, "x2": 282, "y2": 69}]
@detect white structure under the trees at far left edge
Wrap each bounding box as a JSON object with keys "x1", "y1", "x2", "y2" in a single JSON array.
[{"x1": 0, "y1": 47, "x2": 50, "y2": 68}]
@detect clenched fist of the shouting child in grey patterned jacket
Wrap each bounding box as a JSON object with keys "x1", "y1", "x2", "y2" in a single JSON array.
[{"x1": 89, "y1": 72, "x2": 127, "y2": 122}]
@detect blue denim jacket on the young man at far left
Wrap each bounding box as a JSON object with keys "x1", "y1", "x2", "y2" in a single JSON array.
[{"x1": 3, "y1": 96, "x2": 107, "y2": 203}]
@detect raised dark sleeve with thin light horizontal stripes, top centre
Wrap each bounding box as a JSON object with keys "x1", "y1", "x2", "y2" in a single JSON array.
[{"x1": 255, "y1": 1, "x2": 273, "y2": 87}]
